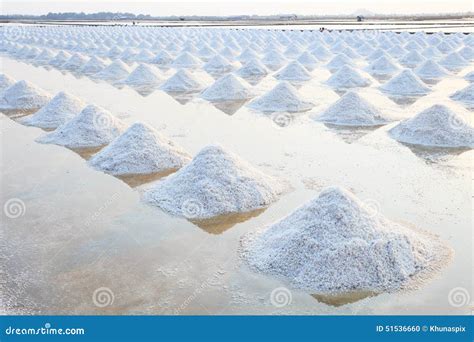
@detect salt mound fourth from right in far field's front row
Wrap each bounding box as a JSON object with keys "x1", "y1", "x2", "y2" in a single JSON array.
[{"x1": 201, "y1": 74, "x2": 253, "y2": 101}]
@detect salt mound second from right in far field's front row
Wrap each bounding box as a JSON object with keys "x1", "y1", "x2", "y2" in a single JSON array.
[{"x1": 315, "y1": 91, "x2": 392, "y2": 126}]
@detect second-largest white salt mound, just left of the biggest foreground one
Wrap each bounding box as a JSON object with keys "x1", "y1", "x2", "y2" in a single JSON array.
[{"x1": 144, "y1": 146, "x2": 284, "y2": 219}]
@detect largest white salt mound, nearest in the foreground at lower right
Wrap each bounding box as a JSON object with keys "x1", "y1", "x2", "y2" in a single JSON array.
[{"x1": 241, "y1": 188, "x2": 450, "y2": 294}]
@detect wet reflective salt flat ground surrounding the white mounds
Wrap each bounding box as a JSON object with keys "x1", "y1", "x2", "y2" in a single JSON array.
[{"x1": 1, "y1": 25, "x2": 474, "y2": 314}]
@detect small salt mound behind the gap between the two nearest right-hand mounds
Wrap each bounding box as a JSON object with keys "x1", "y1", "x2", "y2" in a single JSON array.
[{"x1": 380, "y1": 69, "x2": 431, "y2": 96}]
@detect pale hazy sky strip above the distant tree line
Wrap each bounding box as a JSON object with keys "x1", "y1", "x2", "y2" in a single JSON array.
[{"x1": 0, "y1": 0, "x2": 474, "y2": 16}]
